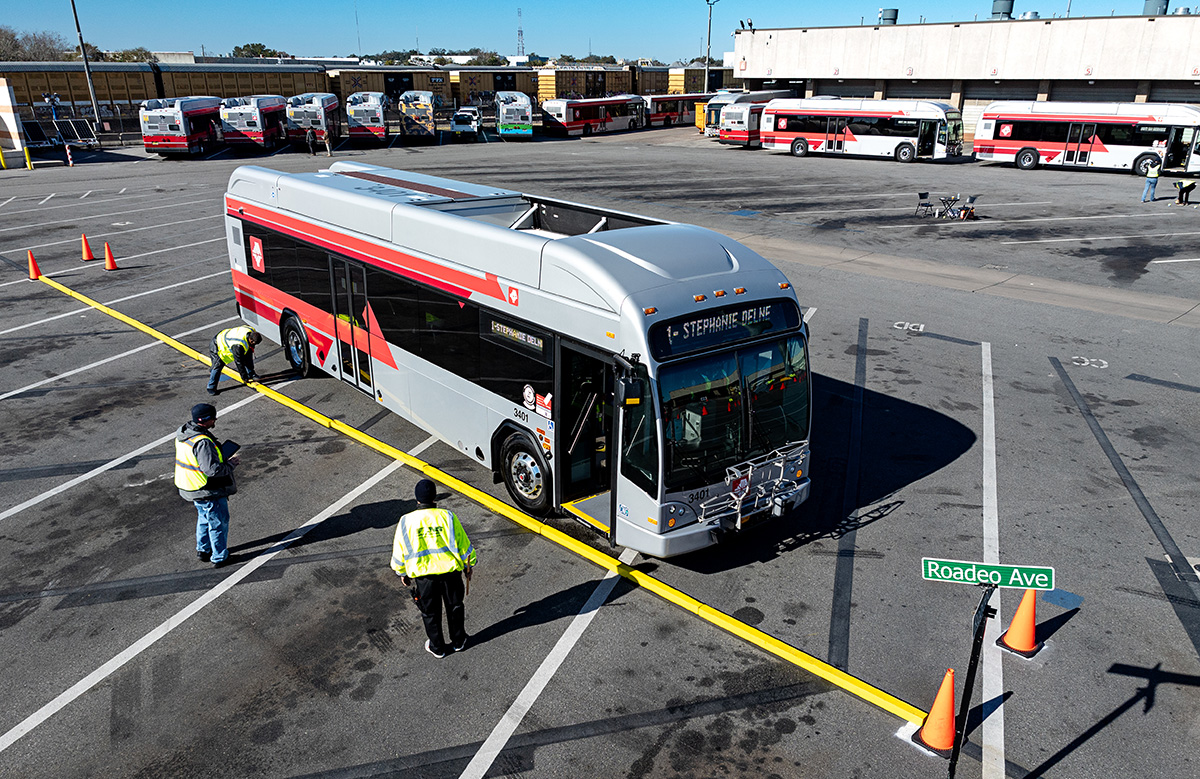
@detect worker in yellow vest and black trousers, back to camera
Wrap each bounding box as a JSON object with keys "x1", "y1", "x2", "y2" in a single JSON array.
[{"x1": 391, "y1": 479, "x2": 476, "y2": 658}]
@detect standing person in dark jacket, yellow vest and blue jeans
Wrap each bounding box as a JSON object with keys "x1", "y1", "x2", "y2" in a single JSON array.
[{"x1": 175, "y1": 403, "x2": 238, "y2": 568}]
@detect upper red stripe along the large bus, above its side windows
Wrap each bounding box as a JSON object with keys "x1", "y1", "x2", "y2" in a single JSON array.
[{"x1": 226, "y1": 196, "x2": 508, "y2": 300}]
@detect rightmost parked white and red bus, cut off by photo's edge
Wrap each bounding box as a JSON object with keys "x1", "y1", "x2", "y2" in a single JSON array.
[{"x1": 974, "y1": 101, "x2": 1200, "y2": 175}]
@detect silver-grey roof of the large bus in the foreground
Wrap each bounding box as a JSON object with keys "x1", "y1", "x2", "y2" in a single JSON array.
[{"x1": 227, "y1": 162, "x2": 786, "y2": 316}]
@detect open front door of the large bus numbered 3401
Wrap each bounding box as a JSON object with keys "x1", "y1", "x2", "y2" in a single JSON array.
[{"x1": 554, "y1": 342, "x2": 613, "y2": 534}]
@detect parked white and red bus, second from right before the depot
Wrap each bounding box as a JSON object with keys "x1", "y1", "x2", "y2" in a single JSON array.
[{"x1": 762, "y1": 97, "x2": 962, "y2": 162}]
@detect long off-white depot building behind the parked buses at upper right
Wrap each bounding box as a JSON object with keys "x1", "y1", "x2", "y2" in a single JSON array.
[{"x1": 733, "y1": 11, "x2": 1200, "y2": 140}]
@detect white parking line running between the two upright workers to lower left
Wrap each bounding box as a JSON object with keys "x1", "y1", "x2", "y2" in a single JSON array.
[{"x1": 0, "y1": 434, "x2": 436, "y2": 753}]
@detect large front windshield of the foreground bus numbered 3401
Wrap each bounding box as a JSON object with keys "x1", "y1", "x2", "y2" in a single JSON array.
[{"x1": 658, "y1": 335, "x2": 810, "y2": 492}]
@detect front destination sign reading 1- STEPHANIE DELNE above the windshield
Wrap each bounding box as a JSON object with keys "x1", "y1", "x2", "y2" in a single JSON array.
[{"x1": 650, "y1": 300, "x2": 800, "y2": 360}]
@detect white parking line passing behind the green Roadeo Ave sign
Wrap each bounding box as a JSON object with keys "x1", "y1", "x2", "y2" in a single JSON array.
[{"x1": 980, "y1": 341, "x2": 1004, "y2": 779}]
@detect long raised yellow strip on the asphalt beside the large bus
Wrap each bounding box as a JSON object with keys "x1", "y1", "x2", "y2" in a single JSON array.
[{"x1": 32, "y1": 276, "x2": 926, "y2": 725}]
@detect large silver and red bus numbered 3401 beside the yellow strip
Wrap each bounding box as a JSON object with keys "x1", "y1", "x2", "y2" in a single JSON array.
[{"x1": 224, "y1": 161, "x2": 812, "y2": 557}]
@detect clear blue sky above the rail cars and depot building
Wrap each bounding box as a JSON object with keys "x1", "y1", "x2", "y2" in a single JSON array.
[{"x1": 7, "y1": 0, "x2": 1171, "y2": 62}]
